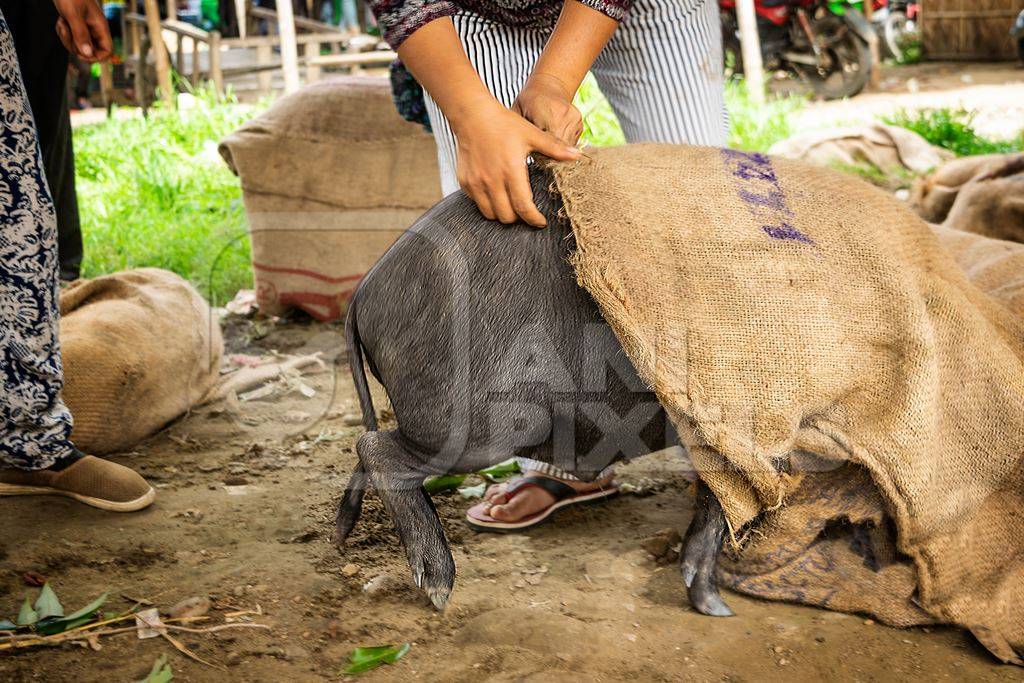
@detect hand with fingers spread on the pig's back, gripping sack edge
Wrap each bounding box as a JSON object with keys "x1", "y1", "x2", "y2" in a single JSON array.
[{"x1": 452, "y1": 99, "x2": 580, "y2": 227}]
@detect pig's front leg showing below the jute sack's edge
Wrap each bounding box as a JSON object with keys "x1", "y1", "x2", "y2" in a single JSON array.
[{"x1": 680, "y1": 480, "x2": 732, "y2": 616}]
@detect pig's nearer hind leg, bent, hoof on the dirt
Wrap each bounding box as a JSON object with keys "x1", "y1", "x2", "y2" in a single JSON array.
[{"x1": 355, "y1": 431, "x2": 455, "y2": 609}]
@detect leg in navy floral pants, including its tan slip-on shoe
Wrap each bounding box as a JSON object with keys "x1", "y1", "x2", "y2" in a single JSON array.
[{"x1": 0, "y1": 7, "x2": 155, "y2": 512}]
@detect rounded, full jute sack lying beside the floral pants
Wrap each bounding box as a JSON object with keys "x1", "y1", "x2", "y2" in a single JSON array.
[{"x1": 60, "y1": 268, "x2": 223, "y2": 454}]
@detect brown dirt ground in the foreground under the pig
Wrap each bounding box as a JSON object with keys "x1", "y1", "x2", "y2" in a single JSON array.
[{"x1": 0, "y1": 323, "x2": 1024, "y2": 682}]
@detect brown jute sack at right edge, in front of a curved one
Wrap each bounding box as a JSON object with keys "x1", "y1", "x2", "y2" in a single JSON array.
[{"x1": 942, "y1": 171, "x2": 1024, "y2": 243}]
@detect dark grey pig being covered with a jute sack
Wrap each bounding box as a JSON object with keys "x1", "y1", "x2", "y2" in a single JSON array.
[{"x1": 333, "y1": 166, "x2": 732, "y2": 616}]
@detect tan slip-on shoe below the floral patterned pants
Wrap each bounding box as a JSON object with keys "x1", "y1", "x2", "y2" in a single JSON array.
[{"x1": 0, "y1": 456, "x2": 157, "y2": 512}]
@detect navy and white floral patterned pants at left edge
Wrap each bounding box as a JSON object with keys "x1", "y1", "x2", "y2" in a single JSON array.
[{"x1": 0, "y1": 9, "x2": 74, "y2": 470}]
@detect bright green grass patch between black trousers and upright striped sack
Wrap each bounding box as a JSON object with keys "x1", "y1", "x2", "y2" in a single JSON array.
[{"x1": 74, "y1": 93, "x2": 260, "y2": 302}]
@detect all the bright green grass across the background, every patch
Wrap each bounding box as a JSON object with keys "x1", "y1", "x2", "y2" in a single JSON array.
[{"x1": 75, "y1": 78, "x2": 1024, "y2": 303}]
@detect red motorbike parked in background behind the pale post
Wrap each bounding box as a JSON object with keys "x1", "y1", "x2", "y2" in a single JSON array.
[{"x1": 719, "y1": 0, "x2": 873, "y2": 99}]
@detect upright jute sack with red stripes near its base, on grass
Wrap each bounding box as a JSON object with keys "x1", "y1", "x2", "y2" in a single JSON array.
[{"x1": 220, "y1": 77, "x2": 440, "y2": 319}]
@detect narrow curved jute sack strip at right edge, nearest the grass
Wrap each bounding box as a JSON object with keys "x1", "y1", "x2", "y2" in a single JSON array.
[{"x1": 910, "y1": 154, "x2": 1024, "y2": 223}]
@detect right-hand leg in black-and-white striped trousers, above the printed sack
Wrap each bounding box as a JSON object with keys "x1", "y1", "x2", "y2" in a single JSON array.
[{"x1": 592, "y1": 0, "x2": 727, "y2": 146}]
